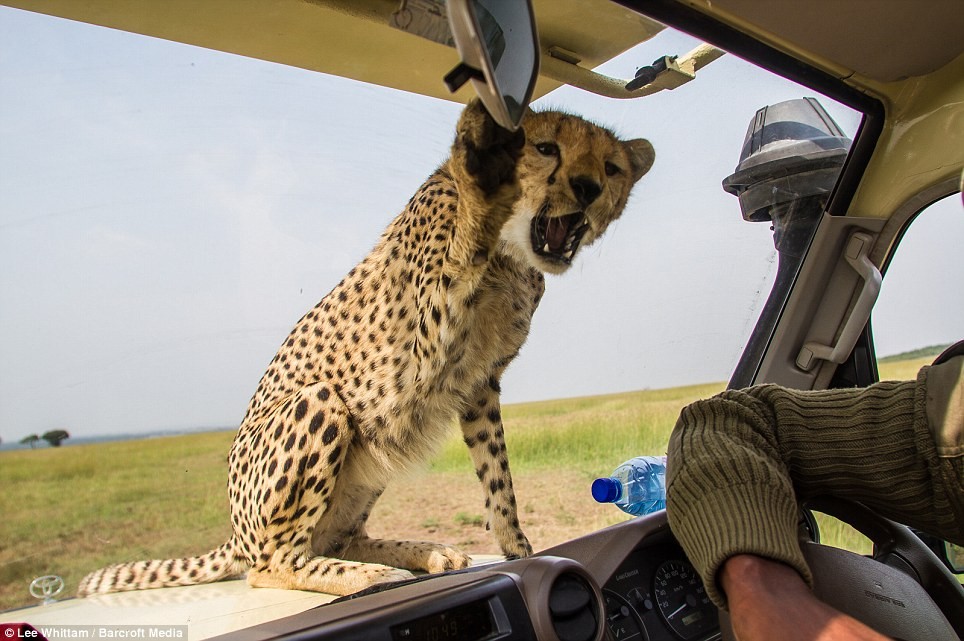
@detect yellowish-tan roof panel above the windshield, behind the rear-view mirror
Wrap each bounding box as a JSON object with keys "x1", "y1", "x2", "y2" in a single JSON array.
[{"x1": 0, "y1": 0, "x2": 663, "y2": 102}]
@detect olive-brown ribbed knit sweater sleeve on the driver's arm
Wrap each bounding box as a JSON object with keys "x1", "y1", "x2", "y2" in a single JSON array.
[{"x1": 667, "y1": 358, "x2": 964, "y2": 607}]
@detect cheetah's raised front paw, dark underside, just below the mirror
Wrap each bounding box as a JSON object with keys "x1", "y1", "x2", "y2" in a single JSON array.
[{"x1": 456, "y1": 99, "x2": 525, "y2": 196}]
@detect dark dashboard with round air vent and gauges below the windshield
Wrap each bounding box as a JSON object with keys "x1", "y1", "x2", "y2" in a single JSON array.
[{"x1": 217, "y1": 512, "x2": 720, "y2": 641}]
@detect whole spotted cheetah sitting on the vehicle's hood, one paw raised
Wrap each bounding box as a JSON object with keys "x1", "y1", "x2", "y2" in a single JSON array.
[{"x1": 80, "y1": 101, "x2": 653, "y2": 594}]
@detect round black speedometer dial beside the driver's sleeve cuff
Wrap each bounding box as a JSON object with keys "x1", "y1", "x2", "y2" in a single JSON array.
[{"x1": 653, "y1": 560, "x2": 719, "y2": 641}]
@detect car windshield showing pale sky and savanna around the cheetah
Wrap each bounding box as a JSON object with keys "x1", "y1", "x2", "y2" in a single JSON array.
[{"x1": 0, "y1": 1, "x2": 936, "y2": 610}]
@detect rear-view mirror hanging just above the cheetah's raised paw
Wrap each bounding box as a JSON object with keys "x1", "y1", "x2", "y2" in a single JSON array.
[{"x1": 445, "y1": 0, "x2": 539, "y2": 131}]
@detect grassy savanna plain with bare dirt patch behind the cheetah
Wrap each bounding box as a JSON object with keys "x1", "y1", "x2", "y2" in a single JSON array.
[{"x1": 0, "y1": 357, "x2": 931, "y2": 610}]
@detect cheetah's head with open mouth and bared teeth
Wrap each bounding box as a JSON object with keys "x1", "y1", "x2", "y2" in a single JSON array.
[{"x1": 502, "y1": 111, "x2": 655, "y2": 274}]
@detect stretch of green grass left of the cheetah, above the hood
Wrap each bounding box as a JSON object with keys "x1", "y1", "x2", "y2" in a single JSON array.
[{"x1": 0, "y1": 432, "x2": 233, "y2": 609}]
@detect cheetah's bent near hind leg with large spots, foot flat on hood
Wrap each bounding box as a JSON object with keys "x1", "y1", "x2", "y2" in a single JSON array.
[{"x1": 242, "y1": 383, "x2": 412, "y2": 595}]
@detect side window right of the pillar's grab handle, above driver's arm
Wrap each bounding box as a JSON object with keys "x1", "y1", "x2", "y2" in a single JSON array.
[{"x1": 872, "y1": 193, "x2": 964, "y2": 380}]
